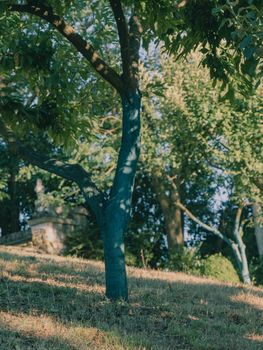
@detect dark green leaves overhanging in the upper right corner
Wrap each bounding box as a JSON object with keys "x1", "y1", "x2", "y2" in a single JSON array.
[{"x1": 130, "y1": 0, "x2": 263, "y2": 95}]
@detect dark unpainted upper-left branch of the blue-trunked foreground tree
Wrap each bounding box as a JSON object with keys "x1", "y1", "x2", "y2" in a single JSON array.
[{"x1": 7, "y1": 4, "x2": 124, "y2": 94}]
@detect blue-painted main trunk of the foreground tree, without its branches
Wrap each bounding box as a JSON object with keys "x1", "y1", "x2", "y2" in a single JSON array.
[{"x1": 101, "y1": 91, "x2": 141, "y2": 300}]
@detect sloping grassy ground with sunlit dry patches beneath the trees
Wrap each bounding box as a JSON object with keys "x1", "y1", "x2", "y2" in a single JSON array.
[{"x1": 0, "y1": 247, "x2": 263, "y2": 350}]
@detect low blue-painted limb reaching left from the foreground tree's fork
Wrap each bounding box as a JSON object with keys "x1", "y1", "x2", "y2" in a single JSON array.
[{"x1": 0, "y1": 119, "x2": 104, "y2": 216}]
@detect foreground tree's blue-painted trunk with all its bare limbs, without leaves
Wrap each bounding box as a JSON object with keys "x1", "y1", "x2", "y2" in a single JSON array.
[{"x1": 1, "y1": 1, "x2": 142, "y2": 300}]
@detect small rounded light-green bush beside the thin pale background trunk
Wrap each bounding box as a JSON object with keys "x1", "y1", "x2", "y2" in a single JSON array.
[{"x1": 200, "y1": 254, "x2": 240, "y2": 283}]
